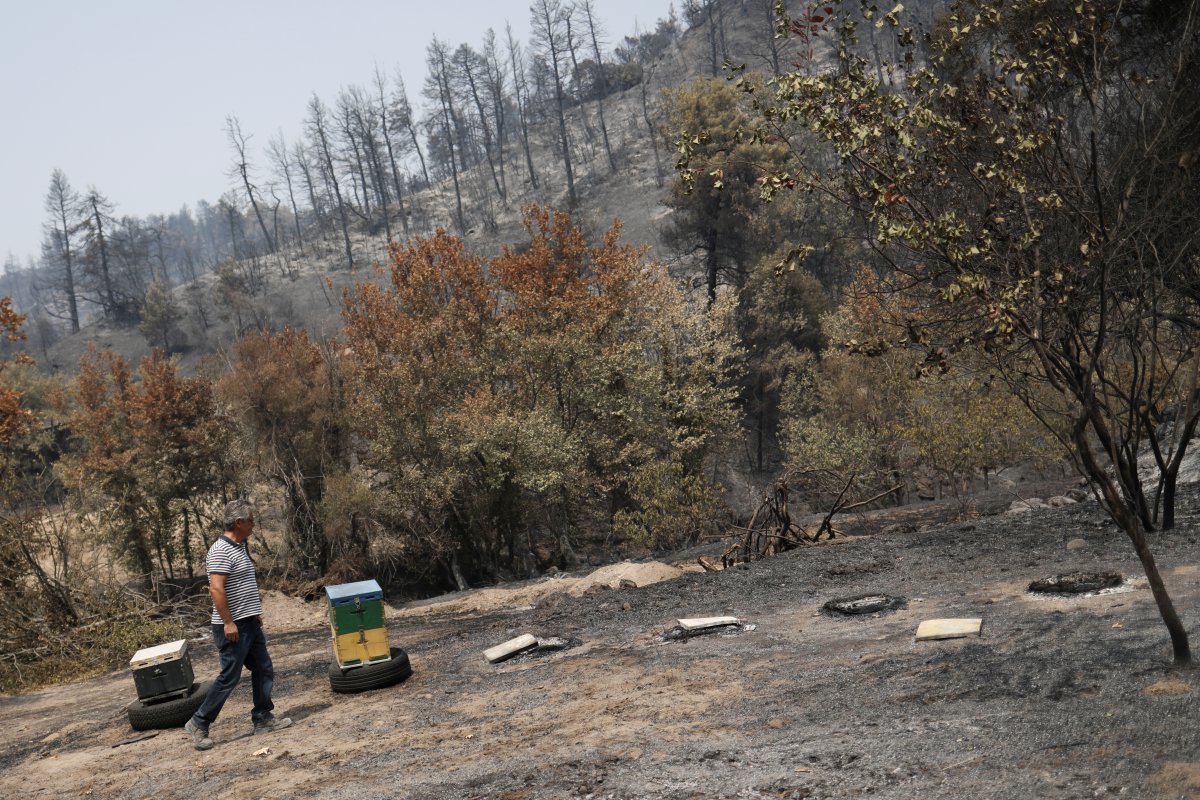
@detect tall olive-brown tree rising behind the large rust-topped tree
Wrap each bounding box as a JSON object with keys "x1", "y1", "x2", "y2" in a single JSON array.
[{"x1": 662, "y1": 79, "x2": 845, "y2": 470}]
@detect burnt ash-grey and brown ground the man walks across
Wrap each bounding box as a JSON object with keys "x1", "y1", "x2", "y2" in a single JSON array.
[{"x1": 0, "y1": 487, "x2": 1200, "y2": 800}]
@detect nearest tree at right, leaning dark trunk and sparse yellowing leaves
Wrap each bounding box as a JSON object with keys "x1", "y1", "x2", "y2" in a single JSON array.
[{"x1": 710, "y1": 0, "x2": 1200, "y2": 663}]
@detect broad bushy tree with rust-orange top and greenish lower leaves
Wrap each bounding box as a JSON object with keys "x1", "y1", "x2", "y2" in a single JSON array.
[{"x1": 346, "y1": 207, "x2": 738, "y2": 582}]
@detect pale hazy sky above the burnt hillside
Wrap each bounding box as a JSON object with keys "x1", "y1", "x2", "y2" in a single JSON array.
[{"x1": 0, "y1": 0, "x2": 671, "y2": 268}]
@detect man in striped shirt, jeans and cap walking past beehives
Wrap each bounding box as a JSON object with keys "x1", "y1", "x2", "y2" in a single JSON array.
[{"x1": 184, "y1": 499, "x2": 292, "y2": 750}]
